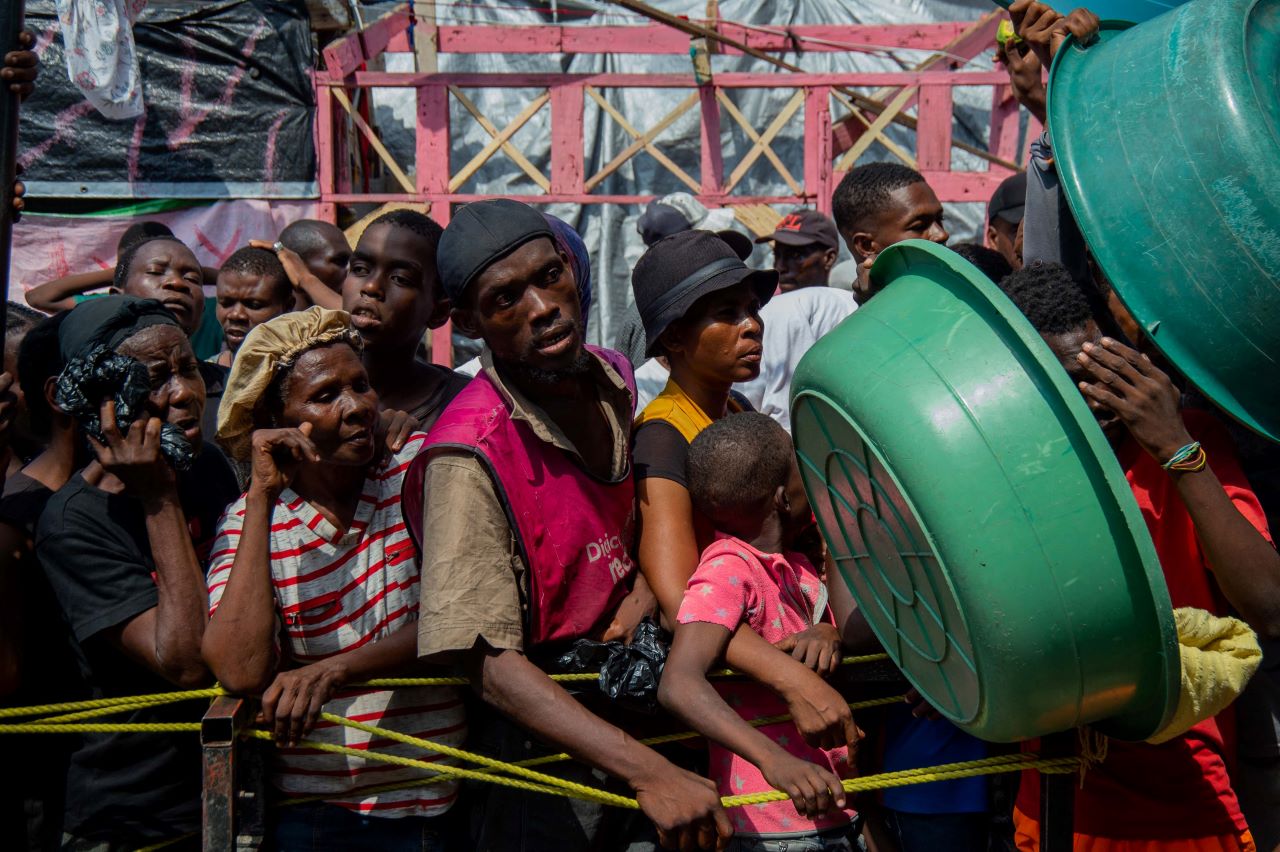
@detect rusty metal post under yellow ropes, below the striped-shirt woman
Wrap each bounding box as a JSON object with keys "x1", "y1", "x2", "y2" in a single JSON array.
[{"x1": 200, "y1": 696, "x2": 266, "y2": 852}]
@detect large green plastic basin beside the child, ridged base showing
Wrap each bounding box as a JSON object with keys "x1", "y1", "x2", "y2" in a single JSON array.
[{"x1": 791, "y1": 241, "x2": 1179, "y2": 742}]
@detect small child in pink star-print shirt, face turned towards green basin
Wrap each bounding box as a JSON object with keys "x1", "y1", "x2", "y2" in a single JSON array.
[{"x1": 658, "y1": 413, "x2": 861, "y2": 852}]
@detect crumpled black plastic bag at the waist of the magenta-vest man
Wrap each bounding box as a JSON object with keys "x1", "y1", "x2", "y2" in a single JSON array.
[{"x1": 556, "y1": 618, "x2": 671, "y2": 713}]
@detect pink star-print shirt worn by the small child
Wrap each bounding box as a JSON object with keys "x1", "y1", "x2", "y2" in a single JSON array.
[{"x1": 677, "y1": 536, "x2": 855, "y2": 835}]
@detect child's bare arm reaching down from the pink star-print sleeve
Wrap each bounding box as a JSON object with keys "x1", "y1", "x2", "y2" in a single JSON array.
[{"x1": 658, "y1": 622, "x2": 845, "y2": 815}]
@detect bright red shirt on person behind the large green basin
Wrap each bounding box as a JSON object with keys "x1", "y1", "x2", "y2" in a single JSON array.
[{"x1": 1018, "y1": 411, "x2": 1270, "y2": 840}]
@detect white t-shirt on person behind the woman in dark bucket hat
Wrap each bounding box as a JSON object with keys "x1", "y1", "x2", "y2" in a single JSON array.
[{"x1": 733, "y1": 287, "x2": 858, "y2": 431}]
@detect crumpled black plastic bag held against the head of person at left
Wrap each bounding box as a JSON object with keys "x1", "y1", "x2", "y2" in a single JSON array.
[{"x1": 55, "y1": 345, "x2": 196, "y2": 471}]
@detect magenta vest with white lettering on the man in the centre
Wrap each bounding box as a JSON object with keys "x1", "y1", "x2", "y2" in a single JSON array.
[{"x1": 403, "y1": 347, "x2": 635, "y2": 649}]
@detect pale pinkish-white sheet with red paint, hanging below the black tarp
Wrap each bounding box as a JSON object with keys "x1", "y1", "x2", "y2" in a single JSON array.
[{"x1": 9, "y1": 200, "x2": 317, "y2": 302}]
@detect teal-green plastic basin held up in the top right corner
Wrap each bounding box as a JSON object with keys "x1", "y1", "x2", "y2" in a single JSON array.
[{"x1": 1048, "y1": 0, "x2": 1280, "y2": 440}]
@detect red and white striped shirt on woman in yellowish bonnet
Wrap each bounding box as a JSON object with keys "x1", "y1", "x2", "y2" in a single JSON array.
[{"x1": 209, "y1": 432, "x2": 466, "y2": 816}]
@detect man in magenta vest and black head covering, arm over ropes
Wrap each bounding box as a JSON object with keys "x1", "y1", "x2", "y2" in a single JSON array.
[{"x1": 404, "y1": 200, "x2": 732, "y2": 852}]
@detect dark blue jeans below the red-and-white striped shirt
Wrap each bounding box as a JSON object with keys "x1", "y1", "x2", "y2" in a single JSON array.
[{"x1": 273, "y1": 802, "x2": 463, "y2": 852}]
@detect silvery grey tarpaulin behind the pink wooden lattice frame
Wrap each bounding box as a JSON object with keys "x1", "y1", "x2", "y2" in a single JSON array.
[{"x1": 366, "y1": 0, "x2": 1008, "y2": 343}]
